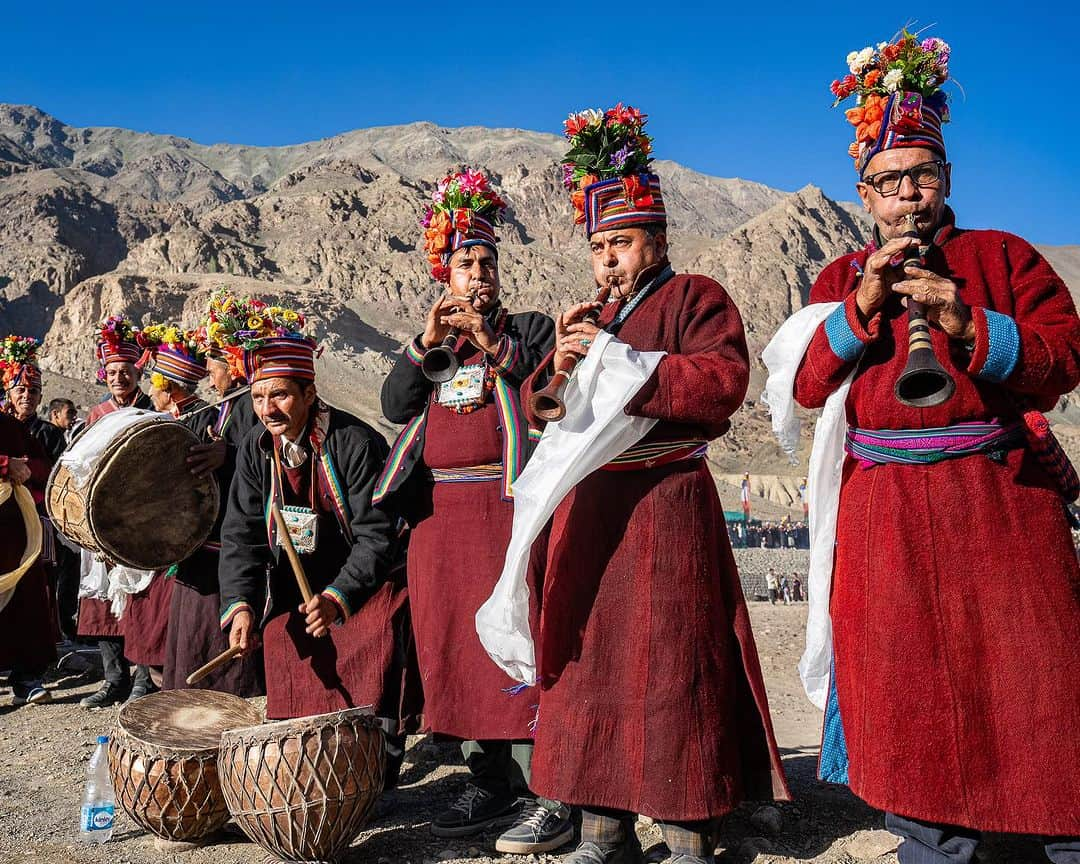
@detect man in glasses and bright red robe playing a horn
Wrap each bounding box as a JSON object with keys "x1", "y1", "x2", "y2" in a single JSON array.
[{"x1": 794, "y1": 33, "x2": 1080, "y2": 864}]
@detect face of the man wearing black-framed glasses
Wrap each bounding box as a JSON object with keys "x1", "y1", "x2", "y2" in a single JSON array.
[{"x1": 855, "y1": 147, "x2": 953, "y2": 241}]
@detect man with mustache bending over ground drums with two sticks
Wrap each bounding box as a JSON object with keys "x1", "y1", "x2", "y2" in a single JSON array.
[{"x1": 218, "y1": 299, "x2": 406, "y2": 779}]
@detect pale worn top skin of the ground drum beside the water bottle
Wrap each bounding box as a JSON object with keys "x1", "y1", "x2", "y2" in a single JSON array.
[{"x1": 117, "y1": 690, "x2": 262, "y2": 752}]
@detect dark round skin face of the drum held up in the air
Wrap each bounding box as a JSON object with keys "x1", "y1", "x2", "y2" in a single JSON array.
[{"x1": 89, "y1": 421, "x2": 218, "y2": 570}]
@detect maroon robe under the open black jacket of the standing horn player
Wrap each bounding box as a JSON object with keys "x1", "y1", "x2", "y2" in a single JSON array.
[{"x1": 408, "y1": 351, "x2": 542, "y2": 740}]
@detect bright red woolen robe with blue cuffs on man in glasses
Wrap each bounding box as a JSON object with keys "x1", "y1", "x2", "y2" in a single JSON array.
[{"x1": 795, "y1": 222, "x2": 1080, "y2": 836}]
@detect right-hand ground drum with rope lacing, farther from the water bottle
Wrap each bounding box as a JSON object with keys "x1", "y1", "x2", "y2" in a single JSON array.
[{"x1": 218, "y1": 708, "x2": 387, "y2": 862}]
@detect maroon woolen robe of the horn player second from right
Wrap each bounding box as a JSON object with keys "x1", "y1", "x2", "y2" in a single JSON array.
[{"x1": 522, "y1": 267, "x2": 786, "y2": 821}]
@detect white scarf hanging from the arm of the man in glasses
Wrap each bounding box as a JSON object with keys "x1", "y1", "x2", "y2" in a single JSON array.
[{"x1": 761, "y1": 302, "x2": 855, "y2": 711}]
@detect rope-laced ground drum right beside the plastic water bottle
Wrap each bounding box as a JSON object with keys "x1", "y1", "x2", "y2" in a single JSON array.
[{"x1": 109, "y1": 690, "x2": 262, "y2": 841}]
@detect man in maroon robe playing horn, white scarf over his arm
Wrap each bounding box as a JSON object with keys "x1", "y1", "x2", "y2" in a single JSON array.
[{"x1": 522, "y1": 106, "x2": 786, "y2": 864}]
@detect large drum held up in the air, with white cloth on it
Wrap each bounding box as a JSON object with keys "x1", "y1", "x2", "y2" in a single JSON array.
[{"x1": 45, "y1": 408, "x2": 218, "y2": 570}]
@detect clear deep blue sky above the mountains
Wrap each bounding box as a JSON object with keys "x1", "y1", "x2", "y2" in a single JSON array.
[{"x1": 0, "y1": 0, "x2": 1080, "y2": 244}]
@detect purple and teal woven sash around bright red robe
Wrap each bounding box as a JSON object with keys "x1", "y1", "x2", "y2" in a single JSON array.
[{"x1": 843, "y1": 420, "x2": 1025, "y2": 468}]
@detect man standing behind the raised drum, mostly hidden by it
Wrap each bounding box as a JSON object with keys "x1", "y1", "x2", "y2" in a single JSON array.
[{"x1": 79, "y1": 315, "x2": 153, "y2": 708}]
